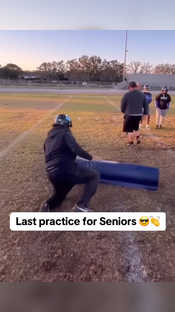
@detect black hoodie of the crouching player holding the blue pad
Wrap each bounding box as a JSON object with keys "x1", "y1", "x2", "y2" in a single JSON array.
[{"x1": 44, "y1": 125, "x2": 92, "y2": 168}]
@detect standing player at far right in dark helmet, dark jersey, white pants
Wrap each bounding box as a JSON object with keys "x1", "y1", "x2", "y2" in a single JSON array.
[{"x1": 155, "y1": 86, "x2": 171, "y2": 129}]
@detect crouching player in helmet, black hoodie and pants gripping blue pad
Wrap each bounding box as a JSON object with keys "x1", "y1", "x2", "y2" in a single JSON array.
[{"x1": 40, "y1": 114, "x2": 101, "y2": 212}]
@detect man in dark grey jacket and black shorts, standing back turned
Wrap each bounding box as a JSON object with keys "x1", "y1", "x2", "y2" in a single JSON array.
[{"x1": 121, "y1": 81, "x2": 148, "y2": 145}]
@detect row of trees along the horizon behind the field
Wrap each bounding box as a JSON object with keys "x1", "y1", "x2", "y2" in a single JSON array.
[{"x1": 0, "y1": 55, "x2": 175, "y2": 82}]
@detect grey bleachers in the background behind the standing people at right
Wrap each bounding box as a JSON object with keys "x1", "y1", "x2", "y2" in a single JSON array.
[{"x1": 121, "y1": 74, "x2": 175, "y2": 91}]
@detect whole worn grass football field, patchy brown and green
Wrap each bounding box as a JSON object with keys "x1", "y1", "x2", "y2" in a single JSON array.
[{"x1": 0, "y1": 93, "x2": 175, "y2": 282}]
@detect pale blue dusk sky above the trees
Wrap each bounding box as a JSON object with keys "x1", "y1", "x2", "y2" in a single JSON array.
[{"x1": 0, "y1": 30, "x2": 175, "y2": 70}]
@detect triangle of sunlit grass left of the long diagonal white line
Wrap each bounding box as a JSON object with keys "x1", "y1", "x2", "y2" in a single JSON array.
[{"x1": 0, "y1": 96, "x2": 66, "y2": 151}]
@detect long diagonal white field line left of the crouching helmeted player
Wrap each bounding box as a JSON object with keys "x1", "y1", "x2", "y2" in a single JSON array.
[{"x1": 0, "y1": 95, "x2": 72, "y2": 158}]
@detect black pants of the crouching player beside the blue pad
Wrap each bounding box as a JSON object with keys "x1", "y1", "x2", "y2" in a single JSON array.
[{"x1": 47, "y1": 163, "x2": 100, "y2": 210}]
